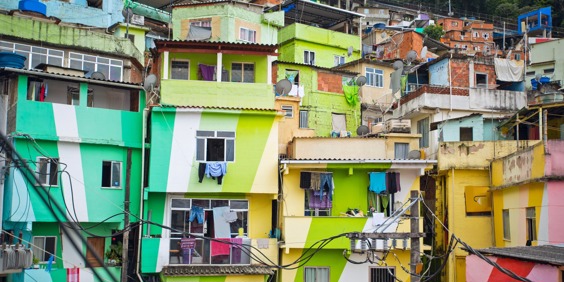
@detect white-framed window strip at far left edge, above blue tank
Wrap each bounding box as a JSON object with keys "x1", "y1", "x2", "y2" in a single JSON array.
[{"x1": 0, "y1": 41, "x2": 64, "y2": 69}]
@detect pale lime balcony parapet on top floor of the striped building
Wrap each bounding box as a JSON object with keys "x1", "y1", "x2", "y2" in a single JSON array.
[{"x1": 161, "y1": 79, "x2": 274, "y2": 109}]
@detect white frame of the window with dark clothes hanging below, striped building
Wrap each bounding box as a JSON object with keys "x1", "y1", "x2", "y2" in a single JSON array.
[{"x1": 196, "y1": 130, "x2": 236, "y2": 163}]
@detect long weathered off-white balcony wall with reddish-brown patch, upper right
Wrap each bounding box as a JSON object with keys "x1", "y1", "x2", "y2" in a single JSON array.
[{"x1": 394, "y1": 84, "x2": 527, "y2": 118}]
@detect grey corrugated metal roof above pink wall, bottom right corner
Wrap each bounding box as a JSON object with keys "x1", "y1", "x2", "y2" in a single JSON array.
[{"x1": 478, "y1": 245, "x2": 564, "y2": 266}]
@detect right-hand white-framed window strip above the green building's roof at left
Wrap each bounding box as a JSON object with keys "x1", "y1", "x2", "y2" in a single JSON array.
[{"x1": 69, "y1": 52, "x2": 123, "y2": 81}]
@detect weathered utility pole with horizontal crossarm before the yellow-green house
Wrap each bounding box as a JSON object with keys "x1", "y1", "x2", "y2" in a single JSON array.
[{"x1": 346, "y1": 190, "x2": 425, "y2": 282}]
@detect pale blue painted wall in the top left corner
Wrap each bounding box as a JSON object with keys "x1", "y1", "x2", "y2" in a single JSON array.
[{"x1": 0, "y1": 0, "x2": 124, "y2": 28}]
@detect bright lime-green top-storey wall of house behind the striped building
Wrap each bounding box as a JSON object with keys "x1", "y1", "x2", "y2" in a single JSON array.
[{"x1": 278, "y1": 24, "x2": 361, "y2": 68}]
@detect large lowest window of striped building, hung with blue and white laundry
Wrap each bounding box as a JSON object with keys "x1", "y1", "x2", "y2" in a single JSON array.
[{"x1": 169, "y1": 198, "x2": 247, "y2": 264}]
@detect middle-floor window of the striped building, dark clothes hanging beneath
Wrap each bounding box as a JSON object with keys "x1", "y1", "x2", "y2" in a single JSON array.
[{"x1": 196, "y1": 130, "x2": 235, "y2": 162}]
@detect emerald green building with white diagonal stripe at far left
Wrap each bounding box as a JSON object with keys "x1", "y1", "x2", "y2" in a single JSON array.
[{"x1": 0, "y1": 68, "x2": 145, "y2": 281}]
